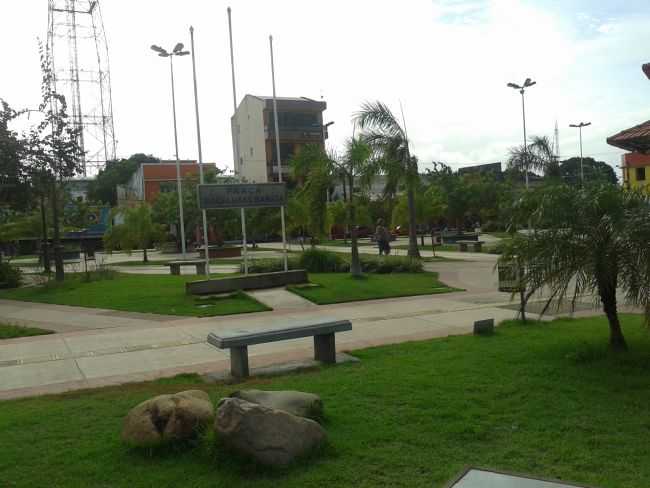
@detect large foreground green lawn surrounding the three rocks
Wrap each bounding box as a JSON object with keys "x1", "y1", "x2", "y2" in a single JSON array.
[{"x1": 0, "y1": 316, "x2": 650, "y2": 488}]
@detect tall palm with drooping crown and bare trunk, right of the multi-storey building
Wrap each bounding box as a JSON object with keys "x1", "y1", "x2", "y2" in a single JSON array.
[{"x1": 355, "y1": 101, "x2": 420, "y2": 258}]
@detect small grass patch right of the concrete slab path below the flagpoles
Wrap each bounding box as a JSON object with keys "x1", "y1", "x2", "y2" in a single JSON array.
[{"x1": 287, "y1": 273, "x2": 456, "y2": 305}]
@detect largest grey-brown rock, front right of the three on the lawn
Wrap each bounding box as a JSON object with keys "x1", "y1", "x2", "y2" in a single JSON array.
[{"x1": 214, "y1": 398, "x2": 327, "y2": 466}]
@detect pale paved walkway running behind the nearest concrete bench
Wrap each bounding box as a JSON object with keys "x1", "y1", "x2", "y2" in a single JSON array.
[{"x1": 0, "y1": 293, "x2": 514, "y2": 399}]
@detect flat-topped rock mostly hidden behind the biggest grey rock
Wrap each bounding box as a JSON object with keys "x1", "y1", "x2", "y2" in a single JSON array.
[{"x1": 230, "y1": 390, "x2": 323, "y2": 420}]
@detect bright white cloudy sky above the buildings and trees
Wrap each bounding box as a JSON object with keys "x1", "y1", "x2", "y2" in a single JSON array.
[{"x1": 0, "y1": 0, "x2": 650, "y2": 174}]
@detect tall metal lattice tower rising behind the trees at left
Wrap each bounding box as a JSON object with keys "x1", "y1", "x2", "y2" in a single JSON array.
[{"x1": 47, "y1": 0, "x2": 115, "y2": 176}]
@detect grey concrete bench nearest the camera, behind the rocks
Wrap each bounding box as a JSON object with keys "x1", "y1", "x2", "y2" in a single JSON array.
[{"x1": 208, "y1": 319, "x2": 352, "y2": 378}]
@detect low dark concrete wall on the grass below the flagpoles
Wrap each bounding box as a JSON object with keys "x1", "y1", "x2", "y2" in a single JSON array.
[{"x1": 185, "y1": 269, "x2": 308, "y2": 295}]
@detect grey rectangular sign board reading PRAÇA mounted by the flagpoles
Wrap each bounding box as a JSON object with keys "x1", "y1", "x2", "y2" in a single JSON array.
[{"x1": 198, "y1": 183, "x2": 287, "y2": 210}]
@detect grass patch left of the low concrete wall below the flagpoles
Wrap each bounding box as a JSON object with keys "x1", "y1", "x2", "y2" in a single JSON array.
[{"x1": 0, "y1": 273, "x2": 269, "y2": 317}]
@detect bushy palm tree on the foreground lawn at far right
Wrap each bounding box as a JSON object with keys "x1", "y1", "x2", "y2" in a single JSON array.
[{"x1": 499, "y1": 183, "x2": 650, "y2": 350}]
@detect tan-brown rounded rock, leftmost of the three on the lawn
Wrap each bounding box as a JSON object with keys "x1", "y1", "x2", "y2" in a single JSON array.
[{"x1": 122, "y1": 390, "x2": 214, "y2": 447}]
